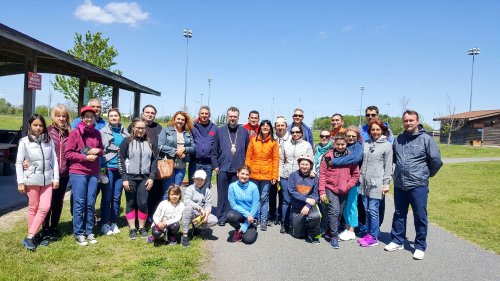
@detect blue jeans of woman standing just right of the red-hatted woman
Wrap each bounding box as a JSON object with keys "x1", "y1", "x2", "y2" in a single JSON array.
[{"x1": 101, "y1": 169, "x2": 123, "y2": 224}]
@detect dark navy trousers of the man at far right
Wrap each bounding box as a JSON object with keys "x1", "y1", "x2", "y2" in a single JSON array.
[{"x1": 391, "y1": 186, "x2": 429, "y2": 251}]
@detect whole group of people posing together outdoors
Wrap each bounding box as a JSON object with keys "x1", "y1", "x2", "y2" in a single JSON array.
[{"x1": 16, "y1": 100, "x2": 442, "y2": 259}]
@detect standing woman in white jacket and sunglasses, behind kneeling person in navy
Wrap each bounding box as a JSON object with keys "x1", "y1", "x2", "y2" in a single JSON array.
[{"x1": 280, "y1": 125, "x2": 314, "y2": 233}]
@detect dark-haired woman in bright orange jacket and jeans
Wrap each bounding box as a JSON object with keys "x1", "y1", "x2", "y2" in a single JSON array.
[{"x1": 245, "y1": 120, "x2": 280, "y2": 231}]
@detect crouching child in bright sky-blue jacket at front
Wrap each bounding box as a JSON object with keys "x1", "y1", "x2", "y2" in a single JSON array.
[{"x1": 226, "y1": 165, "x2": 260, "y2": 244}]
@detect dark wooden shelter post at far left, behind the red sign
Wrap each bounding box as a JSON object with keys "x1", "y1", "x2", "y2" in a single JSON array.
[{"x1": 21, "y1": 54, "x2": 37, "y2": 136}]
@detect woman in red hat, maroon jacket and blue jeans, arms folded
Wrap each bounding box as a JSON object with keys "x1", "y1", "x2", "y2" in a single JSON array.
[{"x1": 64, "y1": 106, "x2": 103, "y2": 246}]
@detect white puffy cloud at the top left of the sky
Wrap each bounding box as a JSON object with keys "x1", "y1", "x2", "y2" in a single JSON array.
[{"x1": 75, "y1": 0, "x2": 149, "y2": 25}]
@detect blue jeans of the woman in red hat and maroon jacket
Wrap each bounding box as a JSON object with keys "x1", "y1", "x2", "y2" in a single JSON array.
[{"x1": 70, "y1": 174, "x2": 97, "y2": 237}]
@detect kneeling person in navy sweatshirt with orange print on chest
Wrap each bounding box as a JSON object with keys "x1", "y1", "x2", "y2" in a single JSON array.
[{"x1": 288, "y1": 154, "x2": 320, "y2": 244}]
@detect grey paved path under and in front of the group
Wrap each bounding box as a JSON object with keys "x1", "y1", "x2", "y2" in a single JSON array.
[{"x1": 205, "y1": 187, "x2": 500, "y2": 281}]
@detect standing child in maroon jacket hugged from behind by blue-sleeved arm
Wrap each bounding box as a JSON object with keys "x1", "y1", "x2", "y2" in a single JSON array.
[{"x1": 319, "y1": 134, "x2": 359, "y2": 249}]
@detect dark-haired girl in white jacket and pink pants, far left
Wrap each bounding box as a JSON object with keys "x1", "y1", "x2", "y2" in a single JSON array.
[{"x1": 16, "y1": 114, "x2": 59, "y2": 251}]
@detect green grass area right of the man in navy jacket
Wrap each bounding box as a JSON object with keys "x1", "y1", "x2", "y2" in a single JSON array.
[{"x1": 428, "y1": 161, "x2": 500, "y2": 254}]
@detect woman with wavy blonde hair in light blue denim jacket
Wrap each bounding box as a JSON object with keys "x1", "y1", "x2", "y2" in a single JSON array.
[{"x1": 158, "y1": 111, "x2": 196, "y2": 200}]
